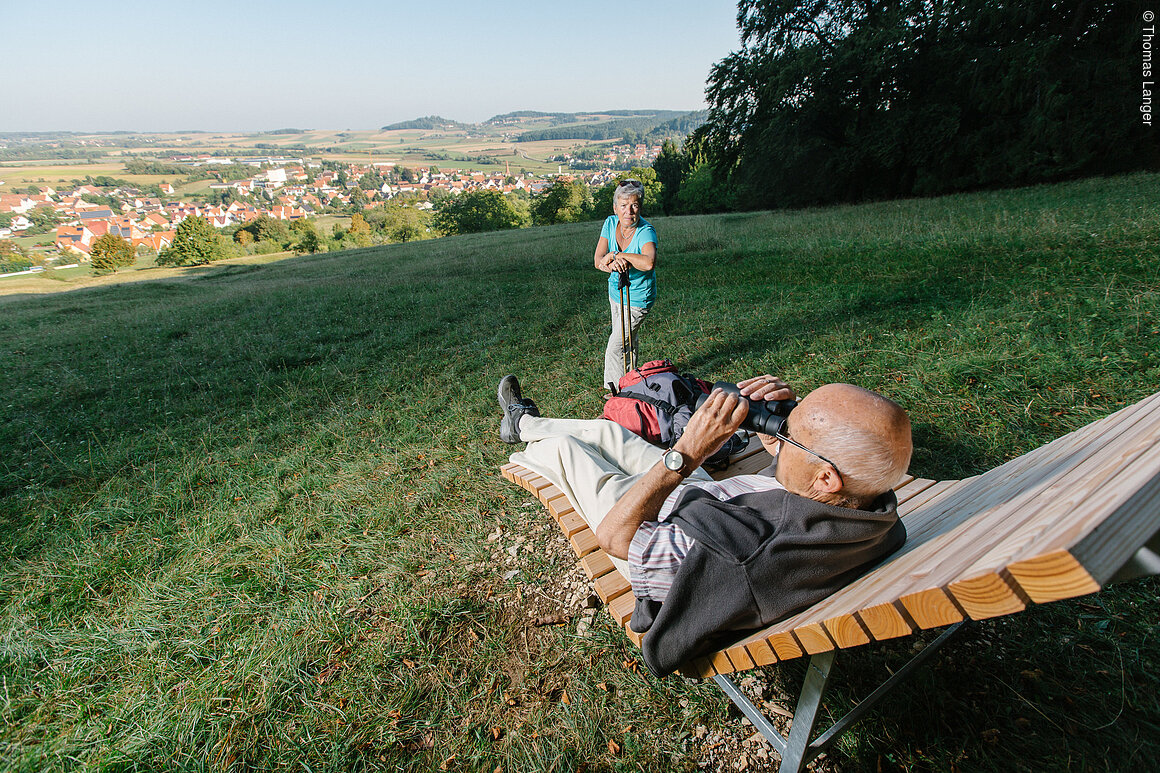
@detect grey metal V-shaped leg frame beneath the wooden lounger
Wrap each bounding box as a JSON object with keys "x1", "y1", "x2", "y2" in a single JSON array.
[{"x1": 713, "y1": 622, "x2": 963, "y2": 773}]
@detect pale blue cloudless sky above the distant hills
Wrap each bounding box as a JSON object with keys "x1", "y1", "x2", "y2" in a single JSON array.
[{"x1": 0, "y1": 0, "x2": 740, "y2": 131}]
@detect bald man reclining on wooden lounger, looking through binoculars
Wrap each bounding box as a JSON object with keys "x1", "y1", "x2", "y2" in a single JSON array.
[{"x1": 498, "y1": 375, "x2": 912, "y2": 676}]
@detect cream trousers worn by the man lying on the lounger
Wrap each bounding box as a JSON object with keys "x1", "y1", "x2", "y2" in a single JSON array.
[{"x1": 512, "y1": 416, "x2": 712, "y2": 578}]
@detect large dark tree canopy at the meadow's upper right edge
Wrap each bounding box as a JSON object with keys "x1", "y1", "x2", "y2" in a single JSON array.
[{"x1": 690, "y1": 0, "x2": 1160, "y2": 208}]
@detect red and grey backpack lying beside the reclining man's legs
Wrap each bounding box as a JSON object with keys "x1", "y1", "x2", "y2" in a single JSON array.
[{"x1": 601, "y1": 360, "x2": 712, "y2": 447}]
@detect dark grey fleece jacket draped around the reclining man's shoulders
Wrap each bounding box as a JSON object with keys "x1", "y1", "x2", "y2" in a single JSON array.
[{"x1": 632, "y1": 487, "x2": 906, "y2": 676}]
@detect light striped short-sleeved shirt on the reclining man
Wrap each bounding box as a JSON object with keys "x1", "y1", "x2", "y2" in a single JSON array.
[{"x1": 629, "y1": 475, "x2": 784, "y2": 601}]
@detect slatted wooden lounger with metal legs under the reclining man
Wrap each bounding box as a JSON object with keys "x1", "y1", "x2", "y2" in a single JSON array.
[{"x1": 502, "y1": 393, "x2": 1160, "y2": 771}]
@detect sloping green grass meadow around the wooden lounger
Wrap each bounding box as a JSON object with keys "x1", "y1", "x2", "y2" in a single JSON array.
[{"x1": 0, "y1": 175, "x2": 1160, "y2": 771}]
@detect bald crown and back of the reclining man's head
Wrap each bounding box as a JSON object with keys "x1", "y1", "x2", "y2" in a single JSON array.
[{"x1": 783, "y1": 384, "x2": 913, "y2": 506}]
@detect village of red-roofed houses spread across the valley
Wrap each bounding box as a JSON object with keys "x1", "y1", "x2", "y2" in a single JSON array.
[{"x1": 0, "y1": 120, "x2": 677, "y2": 275}]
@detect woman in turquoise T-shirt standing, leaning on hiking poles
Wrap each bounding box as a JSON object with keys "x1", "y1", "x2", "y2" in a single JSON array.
[{"x1": 594, "y1": 179, "x2": 657, "y2": 387}]
